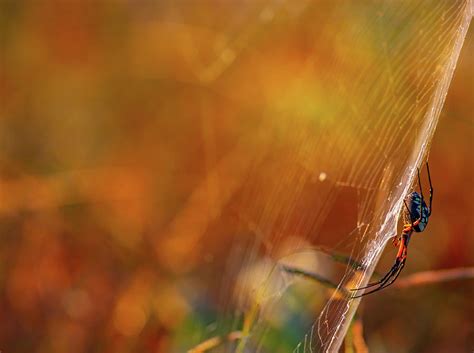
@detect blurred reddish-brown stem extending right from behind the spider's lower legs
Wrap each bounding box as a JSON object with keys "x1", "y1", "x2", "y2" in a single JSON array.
[{"x1": 393, "y1": 267, "x2": 474, "y2": 288}]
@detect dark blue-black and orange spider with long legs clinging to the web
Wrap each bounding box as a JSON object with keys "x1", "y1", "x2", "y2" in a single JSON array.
[{"x1": 351, "y1": 162, "x2": 434, "y2": 298}]
